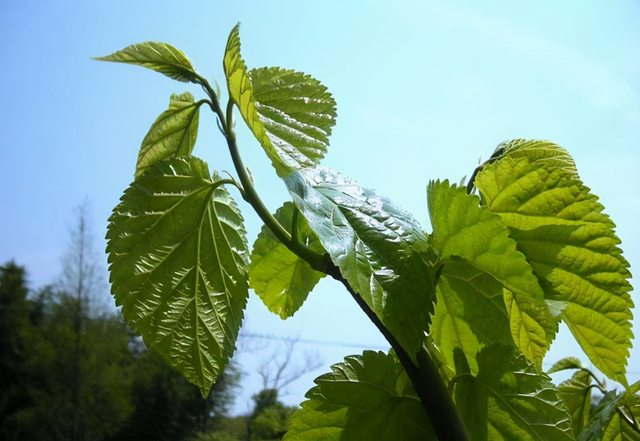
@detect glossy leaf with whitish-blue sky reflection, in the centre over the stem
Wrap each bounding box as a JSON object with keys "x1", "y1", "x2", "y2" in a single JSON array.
[{"x1": 285, "y1": 167, "x2": 435, "y2": 358}]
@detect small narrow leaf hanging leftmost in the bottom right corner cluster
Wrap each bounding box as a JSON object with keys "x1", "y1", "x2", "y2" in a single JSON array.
[{"x1": 556, "y1": 368, "x2": 592, "y2": 436}]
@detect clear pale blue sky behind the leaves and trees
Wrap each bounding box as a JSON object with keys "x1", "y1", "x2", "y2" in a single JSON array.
[{"x1": 0, "y1": 0, "x2": 640, "y2": 412}]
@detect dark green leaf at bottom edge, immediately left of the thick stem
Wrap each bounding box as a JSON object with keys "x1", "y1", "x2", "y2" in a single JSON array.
[{"x1": 284, "y1": 351, "x2": 436, "y2": 441}]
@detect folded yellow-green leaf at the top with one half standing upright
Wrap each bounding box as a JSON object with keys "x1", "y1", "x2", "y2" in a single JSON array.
[{"x1": 223, "y1": 25, "x2": 336, "y2": 177}]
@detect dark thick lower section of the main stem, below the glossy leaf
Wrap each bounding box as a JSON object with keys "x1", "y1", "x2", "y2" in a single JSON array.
[{"x1": 327, "y1": 263, "x2": 469, "y2": 441}]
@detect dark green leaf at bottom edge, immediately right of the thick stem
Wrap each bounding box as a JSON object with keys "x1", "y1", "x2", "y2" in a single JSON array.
[{"x1": 455, "y1": 345, "x2": 573, "y2": 441}]
